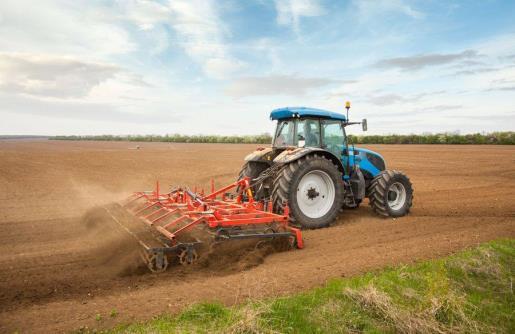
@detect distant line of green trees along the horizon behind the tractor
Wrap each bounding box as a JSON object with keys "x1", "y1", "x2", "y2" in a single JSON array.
[{"x1": 50, "y1": 131, "x2": 515, "y2": 145}]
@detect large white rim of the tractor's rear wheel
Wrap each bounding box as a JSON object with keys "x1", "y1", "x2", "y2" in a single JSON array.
[{"x1": 297, "y1": 170, "x2": 336, "y2": 218}]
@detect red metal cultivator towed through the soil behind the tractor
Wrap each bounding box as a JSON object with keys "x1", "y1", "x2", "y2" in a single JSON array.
[{"x1": 123, "y1": 177, "x2": 303, "y2": 272}]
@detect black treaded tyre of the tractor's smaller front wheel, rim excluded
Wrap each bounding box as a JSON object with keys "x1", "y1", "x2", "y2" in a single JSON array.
[{"x1": 368, "y1": 170, "x2": 413, "y2": 217}]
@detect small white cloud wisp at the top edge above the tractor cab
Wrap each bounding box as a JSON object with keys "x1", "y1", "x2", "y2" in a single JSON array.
[{"x1": 275, "y1": 0, "x2": 326, "y2": 34}]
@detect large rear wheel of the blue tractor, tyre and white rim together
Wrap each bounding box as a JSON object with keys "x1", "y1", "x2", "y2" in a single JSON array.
[{"x1": 272, "y1": 155, "x2": 344, "y2": 228}]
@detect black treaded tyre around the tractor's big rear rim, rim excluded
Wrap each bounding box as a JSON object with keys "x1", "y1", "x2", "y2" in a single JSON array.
[{"x1": 272, "y1": 154, "x2": 344, "y2": 229}]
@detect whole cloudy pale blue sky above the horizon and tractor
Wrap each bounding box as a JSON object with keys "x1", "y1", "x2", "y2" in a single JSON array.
[{"x1": 0, "y1": 0, "x2": 515, "y2": 135}]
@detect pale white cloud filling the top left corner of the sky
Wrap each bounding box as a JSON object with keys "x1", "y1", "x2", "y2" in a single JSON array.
[{"x1": 0, "y1": 0, "x2": 136, "y2": 59}]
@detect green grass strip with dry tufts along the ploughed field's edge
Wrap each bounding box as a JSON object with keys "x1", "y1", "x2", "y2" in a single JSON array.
[{"x1": 94, "y1": 240, "x2": 515, "y2": 333}]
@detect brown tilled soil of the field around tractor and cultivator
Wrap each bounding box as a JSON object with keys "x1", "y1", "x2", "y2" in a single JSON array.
[{"x1": 0, "y1": 141, "x2": 515, "y2": 332}]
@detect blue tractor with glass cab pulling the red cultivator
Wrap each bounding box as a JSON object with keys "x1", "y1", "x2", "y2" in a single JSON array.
[{"x1": 239, "y1": 102, "x2": 413, "y2": 229}]
